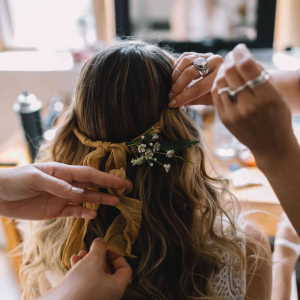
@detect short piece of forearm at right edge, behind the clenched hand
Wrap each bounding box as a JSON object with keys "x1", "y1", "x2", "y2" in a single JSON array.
[{"x1": 272, "y1": 69, "x2": 300, "y2": 113}]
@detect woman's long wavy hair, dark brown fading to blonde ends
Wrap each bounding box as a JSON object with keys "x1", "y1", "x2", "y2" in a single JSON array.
[{"x1": 21, "y1": 42, "x2": 245, "y2": 300}]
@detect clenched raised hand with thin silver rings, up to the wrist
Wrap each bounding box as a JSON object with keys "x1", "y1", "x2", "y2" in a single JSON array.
[{"x1": 213, "y1": 45, "x2": 299, "y2": 165}]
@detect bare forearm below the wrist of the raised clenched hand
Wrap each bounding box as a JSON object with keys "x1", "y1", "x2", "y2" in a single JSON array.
[{"x1": 256, "y1": 142, "x2": 300, "y2": 234}]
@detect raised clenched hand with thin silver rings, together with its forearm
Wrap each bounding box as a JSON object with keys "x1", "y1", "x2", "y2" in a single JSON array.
[{"x1": 213, "y1": 45, "x2": 300, "y2": 233}]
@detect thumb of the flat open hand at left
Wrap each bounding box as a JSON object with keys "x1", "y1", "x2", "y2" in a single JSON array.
[{"x1": 36, "y1": 172, "x2": 84, "y2": 201}]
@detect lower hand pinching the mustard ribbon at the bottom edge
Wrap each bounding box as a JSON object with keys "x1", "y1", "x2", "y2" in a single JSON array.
[{"x1": 40, "y1": 239, "x2": 132, "y2": 300}]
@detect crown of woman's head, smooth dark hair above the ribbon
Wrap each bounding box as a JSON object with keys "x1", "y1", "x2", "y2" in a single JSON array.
[{"x1": 74, "y1": 42, "x2": 173, "y2": 142}]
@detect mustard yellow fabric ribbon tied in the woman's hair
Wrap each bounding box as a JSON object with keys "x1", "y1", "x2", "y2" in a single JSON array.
[{"x1": 62, "y1": 129, "x2": 142, "y2": 269}]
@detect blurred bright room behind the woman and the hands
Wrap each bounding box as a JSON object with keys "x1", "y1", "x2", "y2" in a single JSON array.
[{"x1": 0, "y1": 0, "x2": 300, "y2": 300}]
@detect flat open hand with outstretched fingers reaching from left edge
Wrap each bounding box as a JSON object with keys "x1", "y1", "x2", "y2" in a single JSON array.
[{"x1": 0, "y1": 163, "x2": 131, "y2": 220}]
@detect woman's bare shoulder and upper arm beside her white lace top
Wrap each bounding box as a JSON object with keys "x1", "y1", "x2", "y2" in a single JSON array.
[{"x1": 244, "y1": 223, "x2": 272, "y2": 300}]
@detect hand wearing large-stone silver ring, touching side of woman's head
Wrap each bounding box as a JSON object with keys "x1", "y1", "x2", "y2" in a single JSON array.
[{"x1": 170, "y1": 52, "x2": 223, "y2": 107}]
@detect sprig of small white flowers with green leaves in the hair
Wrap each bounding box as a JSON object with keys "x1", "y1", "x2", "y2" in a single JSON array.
[{"x1": 127, "y1": 127, "x2": 199, "y2": 173}]
